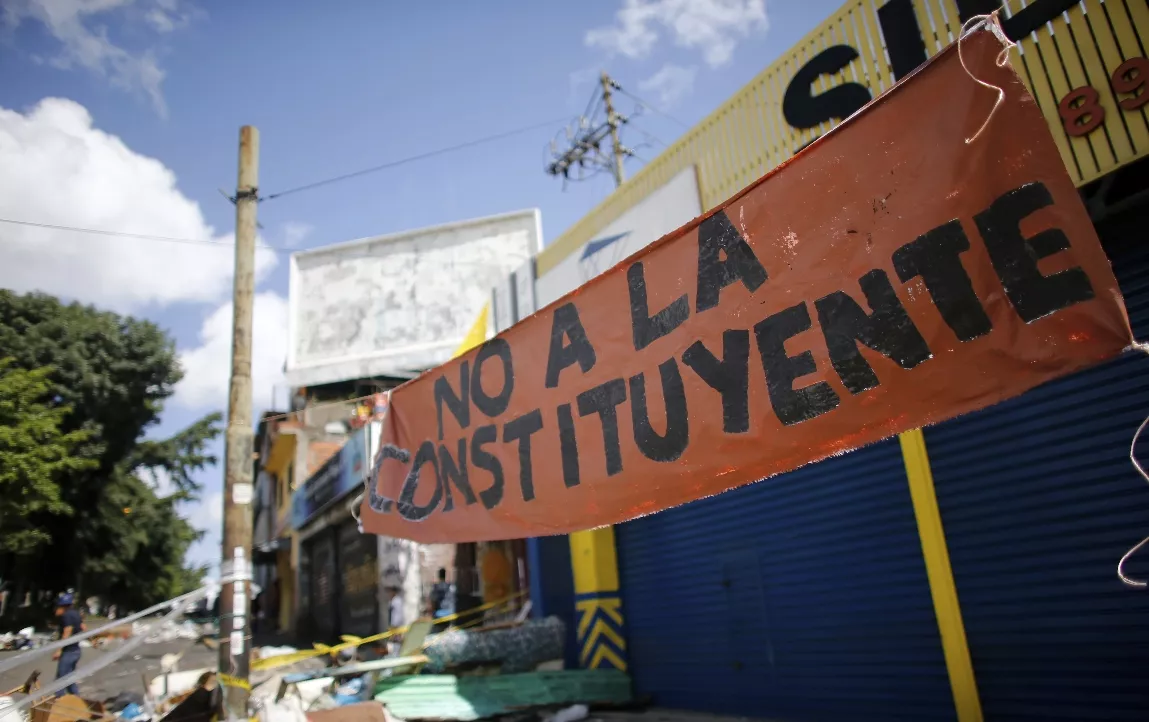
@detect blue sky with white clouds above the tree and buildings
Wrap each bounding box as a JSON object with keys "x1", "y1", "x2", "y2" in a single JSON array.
[{"x1": 0, "y1": 0, "x2": 841, "y2": 570}]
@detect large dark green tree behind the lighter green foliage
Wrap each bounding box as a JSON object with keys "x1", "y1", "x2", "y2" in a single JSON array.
[{"x1": 0, "y1": 291, "x2": 221, "y2": 607}]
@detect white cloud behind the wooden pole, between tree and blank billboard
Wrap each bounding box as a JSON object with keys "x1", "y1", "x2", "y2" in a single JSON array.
[{"x1": 172, "y1": 291, "x2": 287, "y2": 415}]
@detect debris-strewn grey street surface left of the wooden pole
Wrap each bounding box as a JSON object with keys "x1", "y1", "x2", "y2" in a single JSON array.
[{"x1": 0, "y1": 639, "x2": 217, "y2": 700}]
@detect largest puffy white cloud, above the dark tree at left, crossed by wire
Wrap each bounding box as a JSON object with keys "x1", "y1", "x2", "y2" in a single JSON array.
[{"x1": 0, "y1": 97, "x2": 276, "y2": 312}]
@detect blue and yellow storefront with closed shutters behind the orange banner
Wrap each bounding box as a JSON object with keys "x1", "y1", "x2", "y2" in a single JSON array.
[{"x1": 468, "y1": 0, "x2": 1149, "y2": 722}]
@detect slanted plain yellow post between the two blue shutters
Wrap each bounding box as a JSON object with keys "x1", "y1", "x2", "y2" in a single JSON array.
[{"x1": 899, "y1": 429, "x2": 982, "y2": 722}]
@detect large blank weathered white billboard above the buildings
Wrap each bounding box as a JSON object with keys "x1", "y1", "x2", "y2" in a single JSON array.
[{"x1": 286, "y1": 209, "x2": 542, "y2": 387}]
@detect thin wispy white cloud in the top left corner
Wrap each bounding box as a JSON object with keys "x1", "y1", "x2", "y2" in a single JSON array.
[{"x1": 3, "y1": 0, "x2": 192, "y2": 115}]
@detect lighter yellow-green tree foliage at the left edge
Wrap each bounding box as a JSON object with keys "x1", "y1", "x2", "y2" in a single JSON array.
[{"x1": 0, "y1": 359, "x2": 95, "y2": 556}]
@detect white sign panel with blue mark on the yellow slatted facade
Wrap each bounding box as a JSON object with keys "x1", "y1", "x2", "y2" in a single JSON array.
[{"x1": 535, "y1": 166, "x2": 702, "y2": 308}]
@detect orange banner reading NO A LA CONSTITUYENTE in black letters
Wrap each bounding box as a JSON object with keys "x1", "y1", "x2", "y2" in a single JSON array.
[{"x1": 363, "y1": 32, "x2": 1132, "y2": 543}]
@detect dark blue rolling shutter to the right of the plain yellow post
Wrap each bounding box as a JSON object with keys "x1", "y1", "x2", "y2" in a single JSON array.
[{"x1": 925, "y1": 207, "x2": 1149, "y2": 722}]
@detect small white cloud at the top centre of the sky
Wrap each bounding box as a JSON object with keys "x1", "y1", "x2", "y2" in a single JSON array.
[{"x1": 585, "y1": 0, "x2": 768, "y2": 68}]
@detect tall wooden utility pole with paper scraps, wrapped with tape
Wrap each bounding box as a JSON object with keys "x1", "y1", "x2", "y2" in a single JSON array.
[{"x1": 219, "y1": 125, "x2": 260, "y2": 721}]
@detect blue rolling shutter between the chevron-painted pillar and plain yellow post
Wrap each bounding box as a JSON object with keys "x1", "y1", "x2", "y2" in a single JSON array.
[{"x1": 617, "y1": 441, "x2": 955, "y2": 721}]
